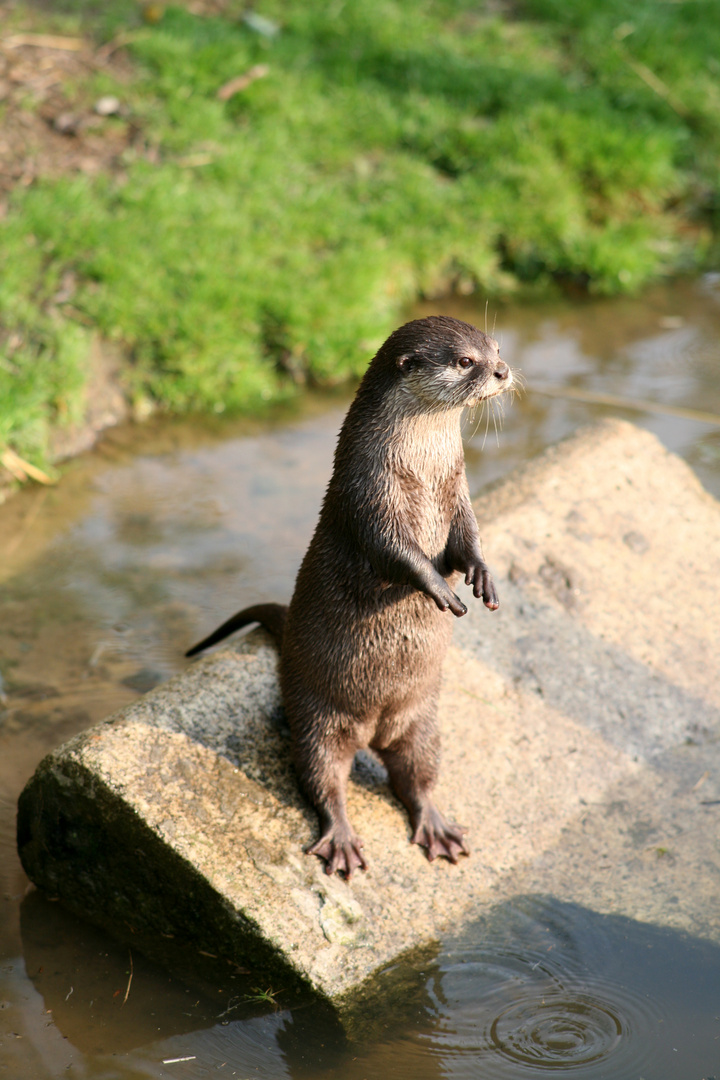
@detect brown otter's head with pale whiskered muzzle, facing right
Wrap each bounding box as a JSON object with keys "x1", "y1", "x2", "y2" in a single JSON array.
[{"x1": 381, "y1": 315, "x2": 513, "y2": 410}]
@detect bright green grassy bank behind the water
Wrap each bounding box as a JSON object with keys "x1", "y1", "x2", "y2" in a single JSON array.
[{"x1": 0, "y1": 0, "x2": 720, "y2": 461}]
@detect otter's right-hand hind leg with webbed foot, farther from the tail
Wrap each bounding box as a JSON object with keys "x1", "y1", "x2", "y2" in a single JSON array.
[{"x1": 376, "y1": 715, "x2": 470, "y2": 863}]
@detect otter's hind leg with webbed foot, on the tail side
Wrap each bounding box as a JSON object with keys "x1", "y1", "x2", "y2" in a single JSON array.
[{"x1": 295, "y1": 737, "x2": 367, "y2": 881}]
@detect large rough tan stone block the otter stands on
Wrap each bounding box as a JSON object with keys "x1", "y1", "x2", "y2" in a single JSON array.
[{"x1": 18, "y1": 421, "x2": 720, "y2": 1004}]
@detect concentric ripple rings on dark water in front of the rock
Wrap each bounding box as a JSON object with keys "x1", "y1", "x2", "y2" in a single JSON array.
[{"x1": 425, "y1": 905, "x2": 664, "y2": 1080}]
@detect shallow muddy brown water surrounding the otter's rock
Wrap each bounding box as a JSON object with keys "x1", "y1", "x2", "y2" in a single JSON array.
[{"x1": 0, "y1": 279, "x2": 720, "y2": 1080}]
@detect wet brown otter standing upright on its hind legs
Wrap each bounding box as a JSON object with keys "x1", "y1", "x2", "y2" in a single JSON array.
[{"x1": 188, "y1": 316, "x2": 513, "y2": 878}]
